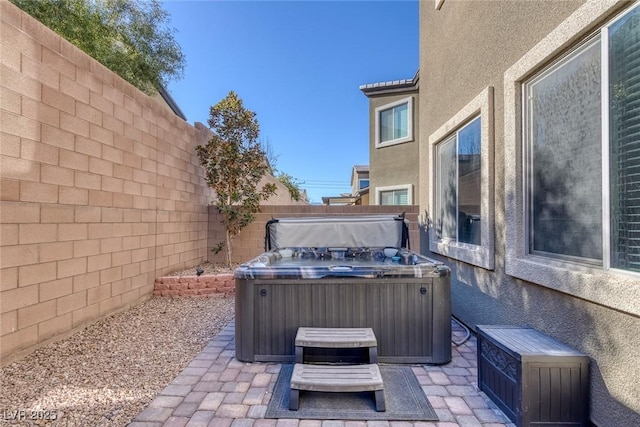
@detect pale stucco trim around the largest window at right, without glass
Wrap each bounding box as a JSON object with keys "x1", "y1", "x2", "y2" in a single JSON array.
[{"x1": 504, "y1": 0, "x2": 640, "y2": 316}]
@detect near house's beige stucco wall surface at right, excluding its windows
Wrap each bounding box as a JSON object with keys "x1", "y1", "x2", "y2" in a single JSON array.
[{"x1": 419, "y1": 0, "x2": 640, "y2": 426}]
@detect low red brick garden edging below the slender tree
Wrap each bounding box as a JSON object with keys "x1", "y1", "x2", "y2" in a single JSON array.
[{"x1": 153, "y1": 273, "x2": 235, "y2": 297}]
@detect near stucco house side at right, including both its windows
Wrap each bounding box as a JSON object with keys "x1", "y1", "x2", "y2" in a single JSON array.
[{"x1": 418, "y1": 0, "x2": 640, "y2": 426}]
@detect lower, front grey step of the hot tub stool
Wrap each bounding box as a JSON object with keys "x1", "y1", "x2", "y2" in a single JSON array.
[{"x1": 289, "y1": 363, "x2": 386, "y2": 412}]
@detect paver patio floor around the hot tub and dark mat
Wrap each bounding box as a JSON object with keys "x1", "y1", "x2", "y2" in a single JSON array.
[{"x1": 129, "y1": 321, "x2": 514, "y2": 427}]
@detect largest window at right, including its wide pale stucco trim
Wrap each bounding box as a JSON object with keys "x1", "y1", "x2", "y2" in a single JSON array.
[{"x1": 504, "y1": 2, "x2": 640, "y2": 316}]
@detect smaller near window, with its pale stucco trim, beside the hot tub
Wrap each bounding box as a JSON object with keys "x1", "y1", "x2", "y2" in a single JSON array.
[{"x1": 430, "y1": 87, "x2": 495, "y2": 270}]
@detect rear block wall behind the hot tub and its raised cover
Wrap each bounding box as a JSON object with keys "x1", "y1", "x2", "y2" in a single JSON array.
[{"x1": 208, "y1": 205, "x2": 420, "y2": 263}]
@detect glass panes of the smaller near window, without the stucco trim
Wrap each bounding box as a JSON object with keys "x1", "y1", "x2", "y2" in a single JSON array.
[{"x1": 436, "y1": 117, "x2": 482, "y2": 245}]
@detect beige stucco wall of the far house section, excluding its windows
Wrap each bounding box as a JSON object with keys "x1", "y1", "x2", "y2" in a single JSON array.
[{"x1": 369, "y1": 90, "x2": 420, "y2": 204}]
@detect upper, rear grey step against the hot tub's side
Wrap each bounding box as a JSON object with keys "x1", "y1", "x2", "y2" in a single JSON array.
[{"x1": 295, "y1": 327, "x2": 378, "y2": 363}]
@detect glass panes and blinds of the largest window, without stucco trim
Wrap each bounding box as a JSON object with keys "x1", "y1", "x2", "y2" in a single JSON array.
[{"x1": 524, "y1": 3, "x2": 640, "y2": 272}]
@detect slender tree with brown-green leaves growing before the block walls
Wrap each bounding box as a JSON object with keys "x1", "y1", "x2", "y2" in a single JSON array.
[{"x1": 196, "y1": 91, "x2": 276, "y2": 265}]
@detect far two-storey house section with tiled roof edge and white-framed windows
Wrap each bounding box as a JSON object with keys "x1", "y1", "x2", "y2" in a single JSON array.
[{"x1": 360, "y1": 73, "x2": 419, "y2": 205}]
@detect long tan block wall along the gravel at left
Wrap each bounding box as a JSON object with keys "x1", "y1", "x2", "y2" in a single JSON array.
[{"x1": 0, "y1": 0, "x2": 211, "y2": 364}]
